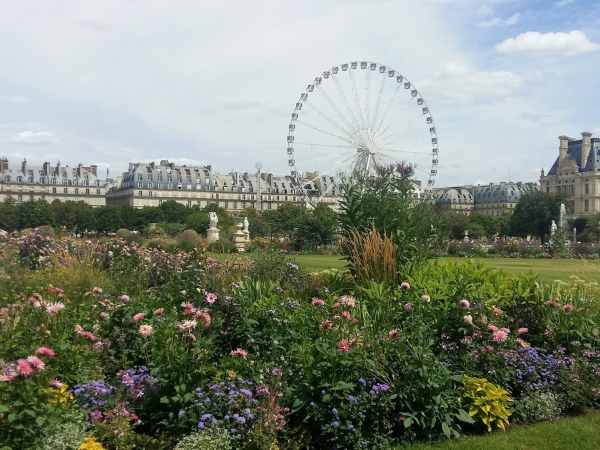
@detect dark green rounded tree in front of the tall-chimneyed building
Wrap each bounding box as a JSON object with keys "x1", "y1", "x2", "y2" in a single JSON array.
[{"x1": 509, "y1": 192, "x2": 567, "y2": 242}]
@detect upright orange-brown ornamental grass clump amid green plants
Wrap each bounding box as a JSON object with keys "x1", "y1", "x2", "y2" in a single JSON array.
[{"x1": 340, "y1": 226, "x2": 398, "y2": 285}]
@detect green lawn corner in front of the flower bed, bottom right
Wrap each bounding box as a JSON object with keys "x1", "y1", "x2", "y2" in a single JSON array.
[{"x1": 406, "y1": 412, "x2": 600, "y2": 450}]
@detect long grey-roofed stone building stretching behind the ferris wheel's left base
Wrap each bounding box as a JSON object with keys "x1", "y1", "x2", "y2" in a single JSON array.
[{"x1": 107, "y1": 160, "x2": 339, "y2": 212}]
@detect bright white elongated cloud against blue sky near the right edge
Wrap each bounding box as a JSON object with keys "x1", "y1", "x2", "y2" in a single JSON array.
[{"x1": 496, "y1": 30, "x2": 600, "y2": 55}]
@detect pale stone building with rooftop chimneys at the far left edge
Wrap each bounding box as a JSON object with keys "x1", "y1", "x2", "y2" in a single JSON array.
[{"x1": 0, "y1": 157, "x2": 106, "y2": 207}]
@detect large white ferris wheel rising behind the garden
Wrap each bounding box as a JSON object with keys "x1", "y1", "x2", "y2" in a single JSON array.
[{"x1": 287, "y1": 61, "x2": 439, "y2": 203}]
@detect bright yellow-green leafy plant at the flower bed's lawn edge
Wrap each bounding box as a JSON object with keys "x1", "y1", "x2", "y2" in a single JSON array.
[{"x1": 459, "y1": 375, "x2": 512, "y2": 431}]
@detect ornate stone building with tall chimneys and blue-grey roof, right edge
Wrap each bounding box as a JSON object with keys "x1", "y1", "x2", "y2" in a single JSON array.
[{"x1": 540, "y1": 132, "x2": 600, "y2": 217}]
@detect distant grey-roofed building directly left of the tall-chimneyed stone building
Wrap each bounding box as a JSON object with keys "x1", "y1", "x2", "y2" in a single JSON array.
[{"x1": 473, "y1": 181, "x2": 539, "y2": 216}]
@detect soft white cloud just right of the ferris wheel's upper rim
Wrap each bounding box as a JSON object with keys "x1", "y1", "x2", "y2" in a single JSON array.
[{"x1": 419, "y1": 62, "x2": 523, "y2": 104}]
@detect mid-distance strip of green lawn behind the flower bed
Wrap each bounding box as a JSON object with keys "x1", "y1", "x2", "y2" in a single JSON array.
[{"x1": 213, "y1": 254, "x2": 600, "y2": 283}]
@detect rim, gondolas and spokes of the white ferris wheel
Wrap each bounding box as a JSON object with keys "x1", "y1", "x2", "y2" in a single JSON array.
[{"x1": 287, "y1": 61, "x2": 439, "y2": 203}]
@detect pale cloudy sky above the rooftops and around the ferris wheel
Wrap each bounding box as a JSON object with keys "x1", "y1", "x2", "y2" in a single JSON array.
[{"x1": 0, "y1": 0, "x2": 600, "y2": 186}]
